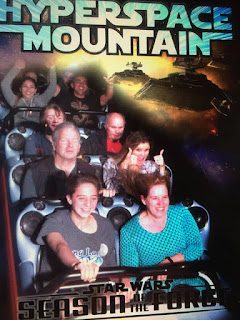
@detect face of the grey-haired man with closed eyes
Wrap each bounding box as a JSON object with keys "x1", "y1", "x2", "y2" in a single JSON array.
[{"x1": 53, "y1": 128, "x2": 80, "y2": 160}]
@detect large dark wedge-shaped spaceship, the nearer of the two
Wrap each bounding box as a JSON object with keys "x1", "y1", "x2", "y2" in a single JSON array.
[{"x1": 134, "y1": 57, "x2": 232, "y2": 116}]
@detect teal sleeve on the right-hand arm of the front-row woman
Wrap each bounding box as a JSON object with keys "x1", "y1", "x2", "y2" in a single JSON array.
[{"x1": 181, "y1": 208, "x2": 203, "y2": 261}]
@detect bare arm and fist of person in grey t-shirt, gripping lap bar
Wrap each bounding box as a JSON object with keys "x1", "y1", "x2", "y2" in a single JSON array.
[{"x1": 46, "y1": 232, "x2": 99, "y2": 282}]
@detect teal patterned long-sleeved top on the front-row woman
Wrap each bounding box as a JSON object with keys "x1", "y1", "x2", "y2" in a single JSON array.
[{"x1": 120, "y1": 205, "x2": 203, "y2": 267}]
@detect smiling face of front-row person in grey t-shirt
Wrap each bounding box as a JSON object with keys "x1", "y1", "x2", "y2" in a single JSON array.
[{"x1": 67, "y1": 182, "x2": 98, "y2": 219}]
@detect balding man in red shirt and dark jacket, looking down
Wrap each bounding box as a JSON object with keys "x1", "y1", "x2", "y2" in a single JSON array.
[{"x1": 81, "y1": 112, "x2": 125, "y2": 156}]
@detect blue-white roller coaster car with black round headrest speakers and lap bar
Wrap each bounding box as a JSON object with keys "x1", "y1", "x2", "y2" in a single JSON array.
[{"x1": 0, "y1": 109, "x2": 237, "y2": 319}]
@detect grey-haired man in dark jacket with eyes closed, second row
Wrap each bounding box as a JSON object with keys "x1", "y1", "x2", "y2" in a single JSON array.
[{"x1": 21, "y1": 122, "x2": 100, "y2": 199}]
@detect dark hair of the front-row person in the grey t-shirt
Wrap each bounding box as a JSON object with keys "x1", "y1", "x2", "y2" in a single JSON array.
[{"x1": 66, "y1": 173, "x2": 100, "y2": 196}]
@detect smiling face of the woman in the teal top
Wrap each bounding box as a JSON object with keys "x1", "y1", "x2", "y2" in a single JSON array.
[{"x1": 141, "y1": 184, "x2": 169, "y2": 218}]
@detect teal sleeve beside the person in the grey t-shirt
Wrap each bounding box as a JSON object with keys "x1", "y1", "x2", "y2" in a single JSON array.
[{"x1": 120, "y1": 223, "x2": 140, "y2": 267}]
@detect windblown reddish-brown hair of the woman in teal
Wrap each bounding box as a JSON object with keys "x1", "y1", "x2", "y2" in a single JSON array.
[{"x1": 122, "y1": 170, "x2": 170, "y2": 200}]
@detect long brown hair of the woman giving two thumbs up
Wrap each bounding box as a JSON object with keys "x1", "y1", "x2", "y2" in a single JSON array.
[{"x1": 112, "y1": 131, "x2": 150, "y2": 165}]
